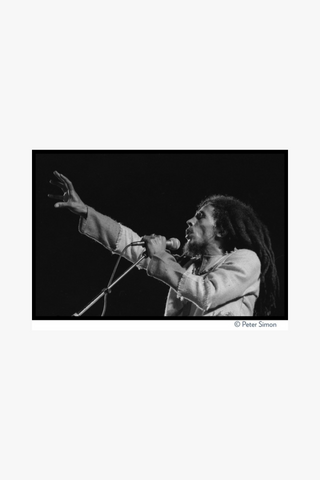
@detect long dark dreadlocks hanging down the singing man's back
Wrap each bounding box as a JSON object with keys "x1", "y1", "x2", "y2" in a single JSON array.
[{"x1": 198, "y1": 195, "x2": 279, "y2": 316}]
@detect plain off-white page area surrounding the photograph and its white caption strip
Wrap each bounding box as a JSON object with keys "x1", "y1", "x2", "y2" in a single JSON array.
[{"x1": 0, "y1": 0, "x2": 319, "y2": 480}]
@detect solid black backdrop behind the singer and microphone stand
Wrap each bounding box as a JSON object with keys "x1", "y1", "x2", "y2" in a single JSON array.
[{"x1": 33, "y1": 150, "x2": 288, "y2": 319}]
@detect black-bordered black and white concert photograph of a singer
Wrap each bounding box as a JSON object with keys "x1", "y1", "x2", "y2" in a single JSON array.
[{"x1": 33, "y1": 150, "x2": 288, "y2": 321}]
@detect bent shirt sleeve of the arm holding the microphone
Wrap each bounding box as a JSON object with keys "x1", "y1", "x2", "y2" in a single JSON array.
[{"x1": 147, "y1": 249, "x2": 261, "y2": 310}]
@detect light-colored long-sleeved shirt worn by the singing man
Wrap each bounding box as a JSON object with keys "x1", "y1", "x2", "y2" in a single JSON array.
[{"x1": 79, "y1": 207, "x2": 261, "y2": 317}]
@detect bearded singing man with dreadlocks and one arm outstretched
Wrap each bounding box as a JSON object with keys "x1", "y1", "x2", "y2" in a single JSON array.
[{"x1": 49, "y1": 172, "x2": 279, "y2": 317}]
